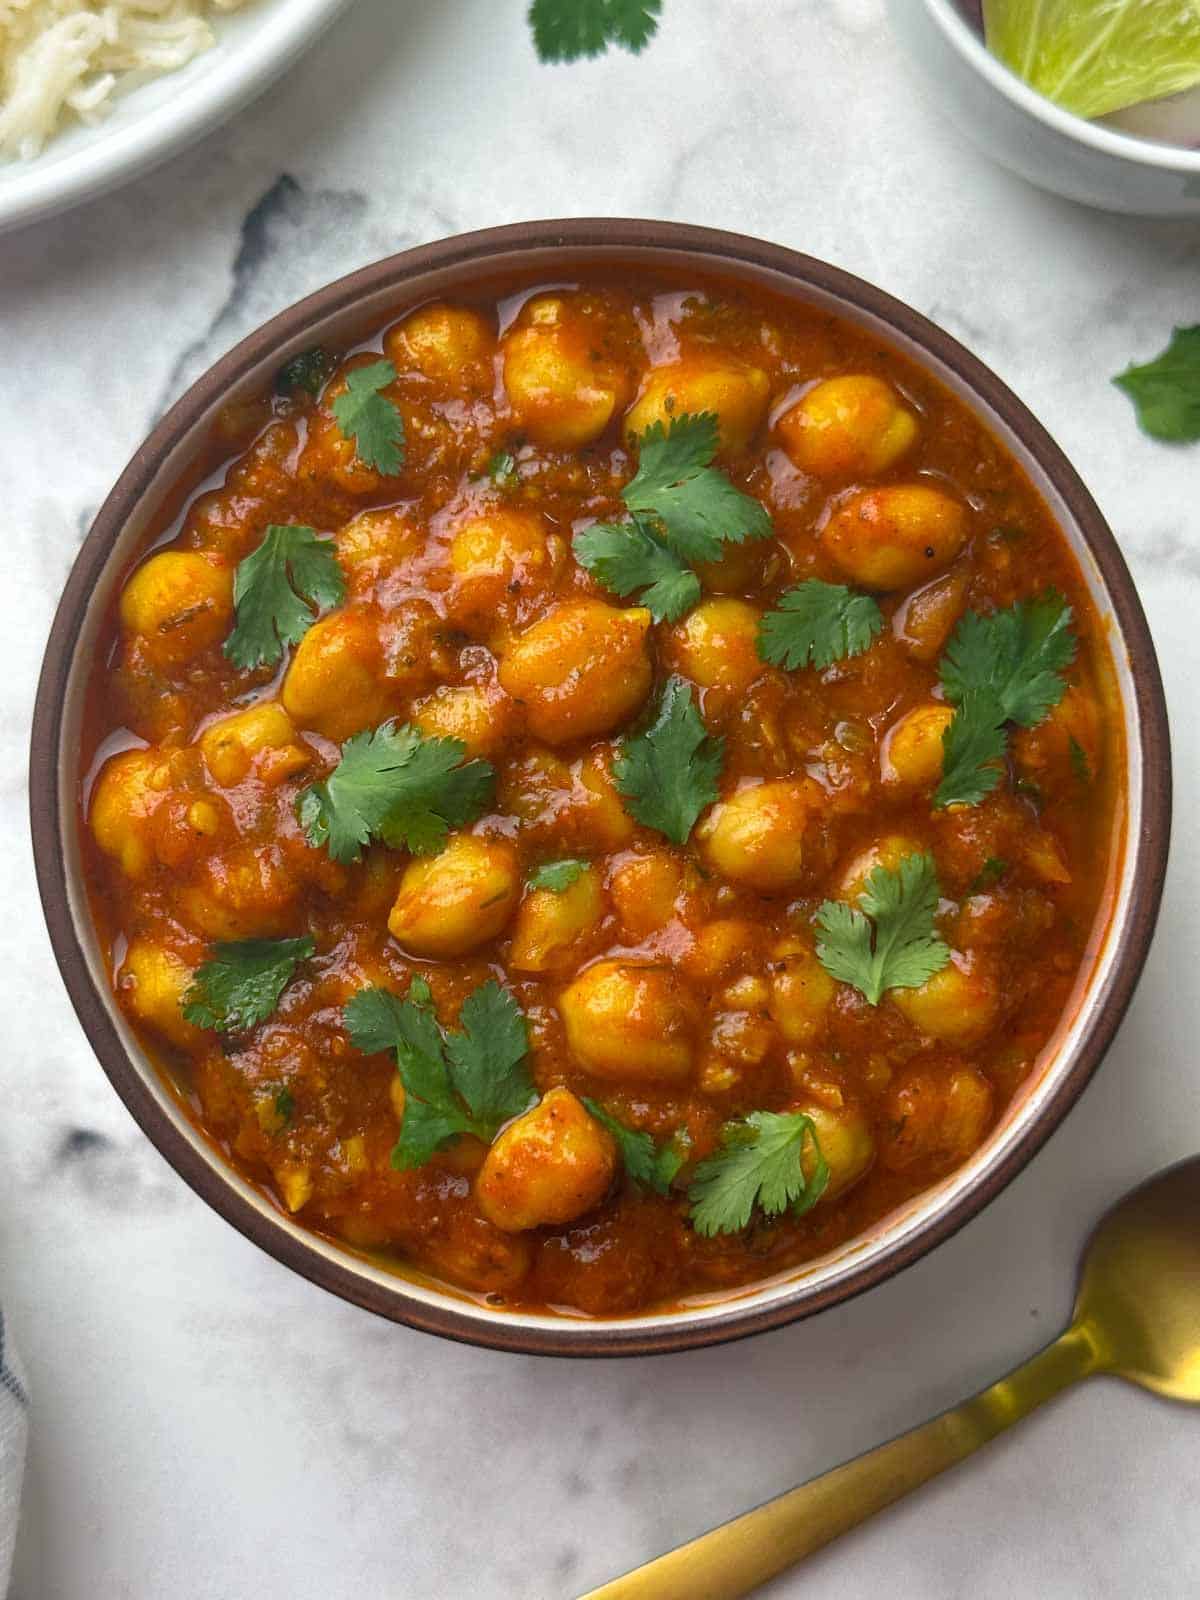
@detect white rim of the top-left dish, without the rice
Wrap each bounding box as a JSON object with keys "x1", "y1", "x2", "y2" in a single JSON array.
[{"x1": 0, "y1": 0, "x2": 349, "y2": 234}]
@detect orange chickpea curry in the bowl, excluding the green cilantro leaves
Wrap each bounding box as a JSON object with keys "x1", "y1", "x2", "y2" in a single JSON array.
[{"x1": 82, "y1": 274, "x2": 1123, "y2": 1315}]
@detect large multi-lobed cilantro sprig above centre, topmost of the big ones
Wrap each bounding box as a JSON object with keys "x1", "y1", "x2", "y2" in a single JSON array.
[{"x1": 573, "y1": 411, "x2": 771, "y2": 622}]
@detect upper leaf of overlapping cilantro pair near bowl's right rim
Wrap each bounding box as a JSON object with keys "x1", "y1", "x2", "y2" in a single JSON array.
[{"x1": 941, "y1": 589, "x2": 1075, "y2": 728}]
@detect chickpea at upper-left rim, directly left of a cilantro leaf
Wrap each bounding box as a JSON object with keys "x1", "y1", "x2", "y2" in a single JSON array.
[{"x1": 120, "y1": 550, "x2": 234, "y2": 667}]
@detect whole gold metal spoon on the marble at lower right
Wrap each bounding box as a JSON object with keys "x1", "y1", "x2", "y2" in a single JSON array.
[{"x1": 581, "y1": 1157, "x2": 1200, "y2": 1600}]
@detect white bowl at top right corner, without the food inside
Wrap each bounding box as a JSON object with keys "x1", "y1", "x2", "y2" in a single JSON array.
[{"x1": 890, "y1": 0, "x2": 1200, "y2": 216}]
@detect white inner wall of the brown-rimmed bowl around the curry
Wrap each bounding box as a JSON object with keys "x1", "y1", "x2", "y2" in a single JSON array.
[{"x1": 59, "y1": 246, "x2": 1142, "y2": 1334}]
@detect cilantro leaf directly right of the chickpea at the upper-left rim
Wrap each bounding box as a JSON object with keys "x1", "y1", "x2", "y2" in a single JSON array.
[{"x1": 222, "y1": 523, "x2": 346, "y2": 669}]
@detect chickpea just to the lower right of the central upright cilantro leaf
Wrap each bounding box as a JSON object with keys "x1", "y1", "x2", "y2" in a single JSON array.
[{"x1": 696, "y1": 779, "x2": 818, "y2": 894}]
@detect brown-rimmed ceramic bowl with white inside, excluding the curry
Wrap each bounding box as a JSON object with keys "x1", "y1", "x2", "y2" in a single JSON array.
[{"x1": 30, "y1": 221, "x2": 1171, "y2": 1355}]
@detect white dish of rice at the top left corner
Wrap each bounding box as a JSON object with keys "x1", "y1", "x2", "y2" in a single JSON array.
[{"x1": 0, "y1": 0, "x2": 349, "y2": 232}]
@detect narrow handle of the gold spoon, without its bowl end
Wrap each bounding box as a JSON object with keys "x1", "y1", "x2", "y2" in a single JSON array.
[{"x1": 579, "y1": 1323, "x2": 1106, "y2": 1600}]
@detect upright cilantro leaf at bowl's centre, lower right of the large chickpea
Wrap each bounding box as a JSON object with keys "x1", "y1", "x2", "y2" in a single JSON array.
[{"x1": 613, "y1": 678, "x2": 725, "y2": 845}]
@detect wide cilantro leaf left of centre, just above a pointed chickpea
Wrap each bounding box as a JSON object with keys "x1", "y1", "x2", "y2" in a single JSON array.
[{"x1": 296, "y1": 722, "x2": 496, "y2": 861}]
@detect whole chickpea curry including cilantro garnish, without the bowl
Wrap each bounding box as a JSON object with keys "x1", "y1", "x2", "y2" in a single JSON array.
[{"x1": 82, "y1": 272, "x2": 1123, "y2": 1317}]
